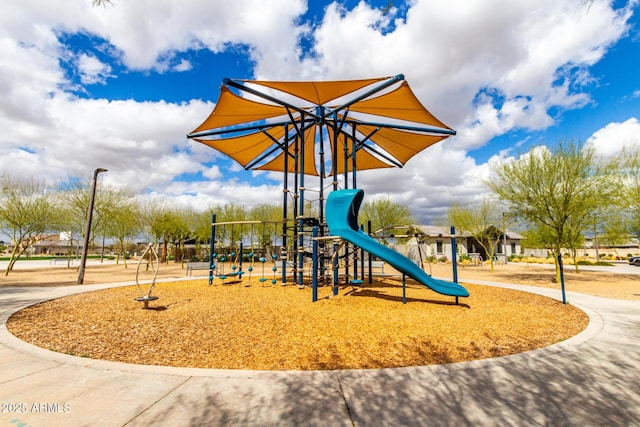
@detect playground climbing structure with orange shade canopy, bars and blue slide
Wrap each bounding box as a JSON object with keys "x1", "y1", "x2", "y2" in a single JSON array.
[{"x1": 188, "y1": 75, "x2": 468, "y2": 301}]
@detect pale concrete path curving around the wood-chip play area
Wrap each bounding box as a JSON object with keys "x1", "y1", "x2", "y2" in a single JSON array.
[{"x1": 0, "y1": 285, "x2": 640, "y2": 427}]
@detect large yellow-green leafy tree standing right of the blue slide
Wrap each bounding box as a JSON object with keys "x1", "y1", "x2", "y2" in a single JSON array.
[{"x1": 486, "y1": 141, "x2": 614, "y2": 281}]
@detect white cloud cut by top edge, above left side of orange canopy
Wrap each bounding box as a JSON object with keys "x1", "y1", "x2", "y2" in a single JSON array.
[{"x1": 81, "y1": 0, "x2": 306, "y2": 72}]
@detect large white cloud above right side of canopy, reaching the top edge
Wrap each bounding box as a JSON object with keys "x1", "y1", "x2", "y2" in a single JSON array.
[{"x1": 304, "y1": 0, "x2": 630, "y2": 148}]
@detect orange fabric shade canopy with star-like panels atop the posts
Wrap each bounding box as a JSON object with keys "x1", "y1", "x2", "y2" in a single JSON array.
[{"x1": 188, "y1": 76, "x2": 455, "y2": 176}]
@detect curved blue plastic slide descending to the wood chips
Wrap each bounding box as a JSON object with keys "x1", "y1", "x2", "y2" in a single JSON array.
[{"x1": 327, "y1": 189, "x2": 469, "y2": 297}]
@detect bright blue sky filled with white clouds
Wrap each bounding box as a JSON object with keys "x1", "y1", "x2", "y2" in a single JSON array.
[{"x1": 0, "y1": 0, "x2": 640, "y2": 223}]
